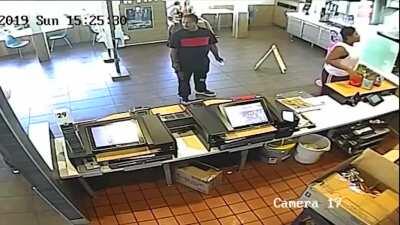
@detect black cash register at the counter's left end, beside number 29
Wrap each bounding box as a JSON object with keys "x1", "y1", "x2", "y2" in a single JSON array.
[{"x1": 61, "y1": 110, "x2": 177, "y2": 170}]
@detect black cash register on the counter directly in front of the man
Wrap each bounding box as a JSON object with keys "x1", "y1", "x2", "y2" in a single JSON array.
[{"x1": 188, "y1": 96, "x2": 284, "y2": 150}]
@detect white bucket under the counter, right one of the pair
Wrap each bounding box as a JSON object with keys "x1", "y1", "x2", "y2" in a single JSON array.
[{"x1": 294, "y1": 134, "x2": 331, "y2": 164}]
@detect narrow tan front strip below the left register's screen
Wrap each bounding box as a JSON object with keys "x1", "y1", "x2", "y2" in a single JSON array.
[{"x1": 96, "y1": 146, "x2": 160, "y2": 162}]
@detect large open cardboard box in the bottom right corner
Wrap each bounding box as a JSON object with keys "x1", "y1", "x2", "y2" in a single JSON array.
[{"x1": 301, "y1": 149, "x2": 399, "y2": 225}]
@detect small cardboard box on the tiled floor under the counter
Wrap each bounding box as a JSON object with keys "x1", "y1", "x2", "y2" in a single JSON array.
[{"x1": 175, "y1": 162, "x2": 223, "y2": 194}]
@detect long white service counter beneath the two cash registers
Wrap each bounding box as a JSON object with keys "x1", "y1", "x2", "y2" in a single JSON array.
[{"x1": 30, "y1": 92, "x2": 399, "y2": 196}]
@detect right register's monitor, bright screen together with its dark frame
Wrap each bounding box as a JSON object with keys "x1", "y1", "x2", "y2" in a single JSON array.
[{"x1": 220, "y1": 100, "x2": 270, "y2": 130}]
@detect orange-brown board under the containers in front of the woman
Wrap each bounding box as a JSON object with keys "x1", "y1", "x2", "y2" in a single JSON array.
[{"x1": 326, "y1": 80, "x2": 397, "y2": 97}]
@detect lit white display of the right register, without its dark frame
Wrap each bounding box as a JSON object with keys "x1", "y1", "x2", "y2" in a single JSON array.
[{"x1": 224, "y1": 102, "x2": 268, "y2": 128}]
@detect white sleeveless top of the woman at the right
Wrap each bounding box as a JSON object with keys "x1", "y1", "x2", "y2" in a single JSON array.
[{"x1": 324, "y1": 42, "x2": 360, "y2": 76}]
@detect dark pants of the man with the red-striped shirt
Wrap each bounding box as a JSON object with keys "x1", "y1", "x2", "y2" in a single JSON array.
[{"x1": 177, "y1": 71, "x2": 208, "y2": 98}]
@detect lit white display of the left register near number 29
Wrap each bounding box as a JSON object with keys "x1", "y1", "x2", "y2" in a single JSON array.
[{"x1": 91, "y1": 120, "x2": 139, "y2": 148}]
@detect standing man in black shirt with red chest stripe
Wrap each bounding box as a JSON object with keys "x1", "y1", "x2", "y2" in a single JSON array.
[{"x1": 169, "y1": 14, "x2": 224, "y2": 104}]
